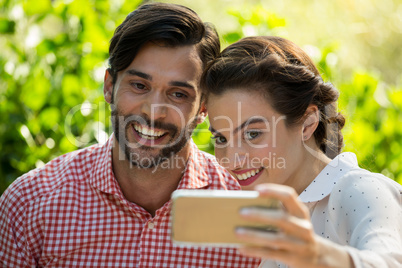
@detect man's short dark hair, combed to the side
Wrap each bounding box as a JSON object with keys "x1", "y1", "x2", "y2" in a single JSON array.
[{"x1": 109, "y1": 3, "x2": 220, "y2": 83}]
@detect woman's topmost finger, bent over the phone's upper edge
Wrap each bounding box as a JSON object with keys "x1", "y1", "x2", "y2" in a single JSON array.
[{"x1": 255, "y1": 183, "x2": 310, "y2": 219}]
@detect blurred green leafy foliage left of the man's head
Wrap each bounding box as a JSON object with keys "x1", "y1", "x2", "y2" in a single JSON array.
[{"x1": 0, "y1": 0, "x2": 140, "y2": 193}]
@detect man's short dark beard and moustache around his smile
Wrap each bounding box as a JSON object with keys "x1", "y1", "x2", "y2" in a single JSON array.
[{"x1": 112, "y1": 108, "x2": 197, "y2": 168}]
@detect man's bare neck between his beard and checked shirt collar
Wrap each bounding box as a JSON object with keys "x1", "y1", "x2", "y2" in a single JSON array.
[{"x1": 112, "y1": 139, "x2": 191, "y2": 216}]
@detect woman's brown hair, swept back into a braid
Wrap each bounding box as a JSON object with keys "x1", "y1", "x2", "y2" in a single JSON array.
[{"x1": 201, "y1": 36, "x2": 345, "y2": 158}]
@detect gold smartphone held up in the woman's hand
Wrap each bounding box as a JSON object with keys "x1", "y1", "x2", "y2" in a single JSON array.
[{"x1": 171, "y1": 189, "x2": 281, "y2": 246}]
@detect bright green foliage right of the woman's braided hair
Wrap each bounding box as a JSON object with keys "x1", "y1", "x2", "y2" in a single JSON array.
[{"x1": 339, "y1": 71, "x2": 402, "y2": 183}]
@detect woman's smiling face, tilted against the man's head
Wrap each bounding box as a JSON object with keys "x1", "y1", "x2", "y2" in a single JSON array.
[{"x1": 207, "y1": 89, "x2": 303, "y2": 190}]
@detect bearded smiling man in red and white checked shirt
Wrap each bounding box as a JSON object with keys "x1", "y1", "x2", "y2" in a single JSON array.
[{"x1": 0, "y1": 3, "x2": 258, "y2": 267}]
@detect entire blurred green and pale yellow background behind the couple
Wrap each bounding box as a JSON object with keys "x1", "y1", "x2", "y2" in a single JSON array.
[{"x1": 0, "y1": 0, "x2": 402, "y2": 194}]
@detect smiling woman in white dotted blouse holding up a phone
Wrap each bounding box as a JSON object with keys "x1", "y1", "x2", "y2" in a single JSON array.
[{"x1": 202, "y1": 37, "x2": 402, "y2": 268}]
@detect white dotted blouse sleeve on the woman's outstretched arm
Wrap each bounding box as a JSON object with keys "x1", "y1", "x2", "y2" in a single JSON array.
[{"x1": 329, "y1": 169, "x2": 402, "y2": 268}]
